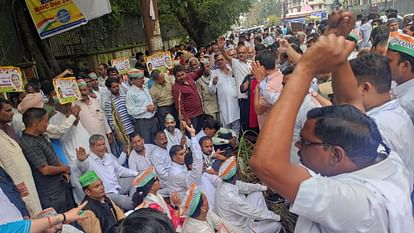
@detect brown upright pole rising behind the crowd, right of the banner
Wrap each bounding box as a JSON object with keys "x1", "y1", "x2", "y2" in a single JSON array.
[{"x1": 141, "y1": 0, "x2": 163, "y2": 54}]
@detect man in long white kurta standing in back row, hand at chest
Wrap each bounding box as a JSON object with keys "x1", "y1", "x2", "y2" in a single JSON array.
[{"x1": 209, "y1": 59, "x2": 240, "y2": 133}]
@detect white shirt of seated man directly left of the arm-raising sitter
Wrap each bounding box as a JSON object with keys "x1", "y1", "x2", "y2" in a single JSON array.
[{"x1": 148, "y1": 146, "x2": 172, "y2": 188}]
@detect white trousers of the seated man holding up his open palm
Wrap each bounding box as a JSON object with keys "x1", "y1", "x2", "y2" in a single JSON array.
[{"x1": 106, "y1": 177, "x2": 135, "y2": 211}]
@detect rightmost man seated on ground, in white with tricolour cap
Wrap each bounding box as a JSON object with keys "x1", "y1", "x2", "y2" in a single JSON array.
[{"x1": 215, "y1": 156, "x2": 282, "y2": 233}]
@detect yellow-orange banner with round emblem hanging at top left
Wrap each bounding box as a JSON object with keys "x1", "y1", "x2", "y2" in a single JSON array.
[{"x1": 26, "y1": 0, "x2": 88, "y2": 39}]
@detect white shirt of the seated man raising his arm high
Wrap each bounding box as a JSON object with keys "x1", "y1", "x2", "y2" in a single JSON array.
[{"x1": 167, "y1": 137, "x2": 203, "y2": 197}]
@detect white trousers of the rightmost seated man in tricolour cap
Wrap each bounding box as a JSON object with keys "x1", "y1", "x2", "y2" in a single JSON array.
[{"x1": 246, "y1": 192, "x2": 282, "y2": 233}]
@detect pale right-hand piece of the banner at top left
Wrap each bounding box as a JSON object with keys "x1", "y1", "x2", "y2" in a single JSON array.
[{"x1": 74, "y1": 0, "x2": 112, "y2": 20}]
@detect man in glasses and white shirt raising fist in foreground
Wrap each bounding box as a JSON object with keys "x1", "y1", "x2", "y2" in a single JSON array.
[{"x1": 250, "y1": 20, "x2": 414, "y2": 232}]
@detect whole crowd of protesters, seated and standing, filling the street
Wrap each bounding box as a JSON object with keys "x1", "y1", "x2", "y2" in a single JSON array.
[{"x1": 0, "y1": 9, "x2": 414, "y2": 233}]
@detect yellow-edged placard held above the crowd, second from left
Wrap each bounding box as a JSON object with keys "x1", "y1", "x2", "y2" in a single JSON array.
[{"x1": 53, "y1": 77, "x2": 82, "y2": 104}]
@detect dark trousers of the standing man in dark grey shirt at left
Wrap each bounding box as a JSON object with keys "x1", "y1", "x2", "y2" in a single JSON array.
[{"x1": 39, "y1": 180, "x2": 76, "y2": 213}]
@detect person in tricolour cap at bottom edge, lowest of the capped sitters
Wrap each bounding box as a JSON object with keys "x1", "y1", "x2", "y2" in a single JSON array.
[{"x1": 181, "y1": 184, "x2": 245, "y2": 233}]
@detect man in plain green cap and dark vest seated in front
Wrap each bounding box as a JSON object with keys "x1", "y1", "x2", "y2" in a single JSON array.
[{"x1": 78, "y1": 171, "x2": 125, "y2": 233}]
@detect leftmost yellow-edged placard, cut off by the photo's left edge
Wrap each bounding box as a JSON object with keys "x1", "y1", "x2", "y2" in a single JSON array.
[{"x1": 0, "y1": 66, "x2": 24, "y2": 92}]
